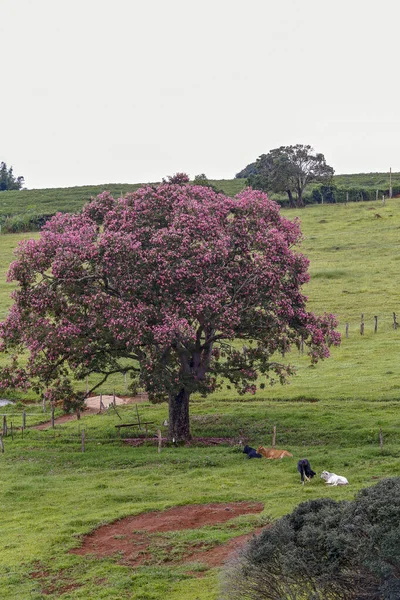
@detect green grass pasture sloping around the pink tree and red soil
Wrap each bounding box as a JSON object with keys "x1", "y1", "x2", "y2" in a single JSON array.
[{"x1": 0, "y1": 199, "x2": 400, "y2": 600}]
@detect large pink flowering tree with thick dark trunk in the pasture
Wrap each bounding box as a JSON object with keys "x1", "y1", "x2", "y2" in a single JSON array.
[{"x1": 0, "y1": 183, "x2": 339, "y2": 441}]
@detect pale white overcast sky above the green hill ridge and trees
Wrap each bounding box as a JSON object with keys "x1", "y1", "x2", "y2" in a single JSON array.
[{"x1": 0, "y1": 0, "x2": 400, "y2": 188}]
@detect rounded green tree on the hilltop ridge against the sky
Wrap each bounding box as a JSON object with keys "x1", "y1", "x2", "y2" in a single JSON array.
[{"x1": 247, "y1": 144, "x2": 335, "y2": 207}]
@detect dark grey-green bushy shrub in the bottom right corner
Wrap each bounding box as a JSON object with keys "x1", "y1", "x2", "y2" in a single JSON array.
[{"x1": 221, "y1": 478, "x2": 400, "y2": 600}]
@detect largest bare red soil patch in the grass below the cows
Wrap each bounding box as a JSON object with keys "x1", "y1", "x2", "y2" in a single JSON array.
[{"x1": 71, "y1": 502, "x2": 264, "y2": 567}]
